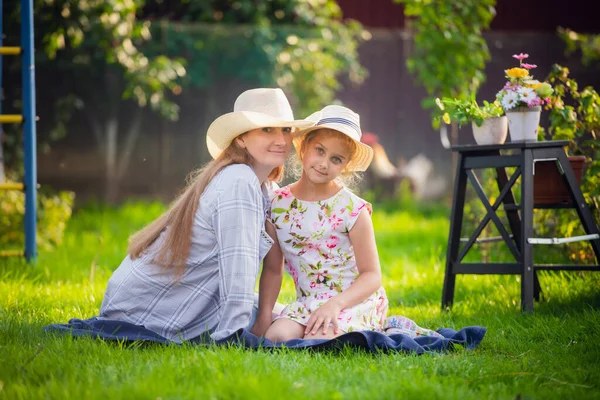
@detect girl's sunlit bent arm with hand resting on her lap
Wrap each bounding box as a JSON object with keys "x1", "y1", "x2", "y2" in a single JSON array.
[{"x1": 305, "y1": 208, "x2": 381, "y2": 334}]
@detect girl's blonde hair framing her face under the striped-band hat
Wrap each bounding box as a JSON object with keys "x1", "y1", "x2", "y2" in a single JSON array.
[{"x1": 289, "y1": 128, "x2": 361, "y2": 188}]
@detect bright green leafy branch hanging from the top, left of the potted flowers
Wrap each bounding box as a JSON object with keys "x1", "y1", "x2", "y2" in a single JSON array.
[{"x1": 395, "y1": 0, "x2": 496, "y2": 123}]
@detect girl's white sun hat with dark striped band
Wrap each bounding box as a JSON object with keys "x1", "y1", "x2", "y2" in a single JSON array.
[{"x1": 293, "y1": 105, "x2": 373, "y2": 171}]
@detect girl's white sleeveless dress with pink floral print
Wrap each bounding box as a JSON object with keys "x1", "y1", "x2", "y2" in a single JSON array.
[{"x1": 270, "y1": 186, "x2": 387, "y2": 332}]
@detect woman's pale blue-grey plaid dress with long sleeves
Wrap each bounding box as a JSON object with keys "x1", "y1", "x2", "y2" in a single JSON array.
[{"x1": 99, "y1": 164, "x2": 274, "y2": 342}]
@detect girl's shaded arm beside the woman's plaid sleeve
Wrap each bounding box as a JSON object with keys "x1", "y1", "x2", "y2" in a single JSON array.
[{"x1": 252, "y1": 221, "x2": 283, "y2": 336}]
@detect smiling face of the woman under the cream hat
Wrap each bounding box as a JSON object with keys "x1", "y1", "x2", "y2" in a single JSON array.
[{"x1": 236, "y1": 127, "x2": 292, "y2": 169}]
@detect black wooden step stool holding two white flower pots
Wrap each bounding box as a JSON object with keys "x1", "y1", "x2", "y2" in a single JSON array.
[{"x1": 442, "y1": 140, "x2": 600, "y2": 312}]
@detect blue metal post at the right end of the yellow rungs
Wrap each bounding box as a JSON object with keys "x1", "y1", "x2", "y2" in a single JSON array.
[{"x1": 21, "y1": 0, "x2": 37, "y2": 262}]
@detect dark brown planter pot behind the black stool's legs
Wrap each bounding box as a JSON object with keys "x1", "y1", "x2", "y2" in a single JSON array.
[{"x1": 533, "y1": 156, "x2": 585, "y2": 205}]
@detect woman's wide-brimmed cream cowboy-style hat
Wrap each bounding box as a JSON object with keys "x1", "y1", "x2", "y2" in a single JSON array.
[{"x1": 206, "y1": 88, "x2": 315, "y2": 158}]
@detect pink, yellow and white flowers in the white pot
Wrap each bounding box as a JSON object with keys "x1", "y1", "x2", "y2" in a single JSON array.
[{"x1": 496, "y1": 53, "x2": 554, "y2": 110}]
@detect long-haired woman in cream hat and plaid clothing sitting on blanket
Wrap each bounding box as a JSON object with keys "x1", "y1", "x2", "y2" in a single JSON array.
[{"x1": 99, "y1": 89, "x2": 314, "y2": 342}]
